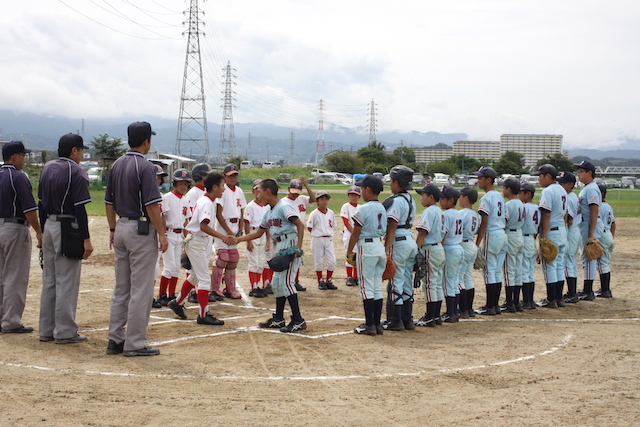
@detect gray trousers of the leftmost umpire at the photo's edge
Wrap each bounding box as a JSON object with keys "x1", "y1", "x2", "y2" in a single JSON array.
[{"x1": 0, "y1": 224, "x2": 31, "y2": 329}]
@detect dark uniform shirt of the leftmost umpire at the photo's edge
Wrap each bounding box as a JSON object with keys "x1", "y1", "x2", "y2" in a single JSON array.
[{"x1": 0, "y1": 164, "x2": 38, "y2": 219}]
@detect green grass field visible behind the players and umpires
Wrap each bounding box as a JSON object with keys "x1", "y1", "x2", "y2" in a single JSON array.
[{"x1": 87, "y1": 185, "x2": 640, "y2": 218}]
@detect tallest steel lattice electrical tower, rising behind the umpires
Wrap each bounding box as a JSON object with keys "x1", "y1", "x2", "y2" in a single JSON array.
[{"x1": 176, "y1": 0, "x2": 209, "y2": 162}]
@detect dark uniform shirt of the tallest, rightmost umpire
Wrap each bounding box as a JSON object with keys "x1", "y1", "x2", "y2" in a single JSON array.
[{"x1": 104, "y1": 150, "x2": 162, "y2": 218}]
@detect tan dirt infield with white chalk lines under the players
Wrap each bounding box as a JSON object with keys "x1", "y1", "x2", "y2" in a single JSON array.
[{"x1": 0, "y1": 217, "x2": 640, "y2": 427}]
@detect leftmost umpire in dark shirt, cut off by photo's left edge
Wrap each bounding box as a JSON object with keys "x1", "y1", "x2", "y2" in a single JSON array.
[{"x1": 0, "y1": 141, "x2": 42, "y2": 334}]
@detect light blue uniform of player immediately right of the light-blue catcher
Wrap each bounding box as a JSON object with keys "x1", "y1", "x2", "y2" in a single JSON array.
[{"x1": 416, "y1": 205, "x2": 445, "y2": 302}]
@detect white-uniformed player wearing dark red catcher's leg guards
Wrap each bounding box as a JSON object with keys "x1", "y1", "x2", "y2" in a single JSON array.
[{"x1": 211, "y1": 164, "x2": 247, "y2": 299}]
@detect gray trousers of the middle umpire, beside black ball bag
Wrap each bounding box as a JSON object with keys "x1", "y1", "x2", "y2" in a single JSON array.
[{"x1": 39, "y1": 220, "x2": 82, "y2": 339}]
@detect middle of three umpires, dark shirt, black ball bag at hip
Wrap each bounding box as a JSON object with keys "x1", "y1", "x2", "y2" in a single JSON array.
[{"x1": 38, "y1": 133, "x2": 93, "y2": 344}]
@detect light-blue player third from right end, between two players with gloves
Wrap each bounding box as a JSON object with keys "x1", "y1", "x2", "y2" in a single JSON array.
[{"x1": 557, "y1": 172, "x2": 582, "y2": 304}]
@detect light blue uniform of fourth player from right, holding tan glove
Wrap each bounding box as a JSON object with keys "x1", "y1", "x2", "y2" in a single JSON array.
[{"x1": 538, "y1": 182, "x2": 567, "y2": 283}]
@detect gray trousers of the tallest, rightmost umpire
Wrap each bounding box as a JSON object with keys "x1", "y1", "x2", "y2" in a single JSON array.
[{"x1": 109, "y1": 218, "x2": 158, "y2": 351}]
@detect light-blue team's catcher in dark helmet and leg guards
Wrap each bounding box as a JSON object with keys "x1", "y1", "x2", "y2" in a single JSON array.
[{"x1": 383, "y1": 165, "x2": 418, "y2": 331}]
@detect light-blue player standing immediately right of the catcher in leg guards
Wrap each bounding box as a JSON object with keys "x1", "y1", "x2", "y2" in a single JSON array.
[{"x1": 415, "y1": 184, "x2": 445, "y2": 327}]
